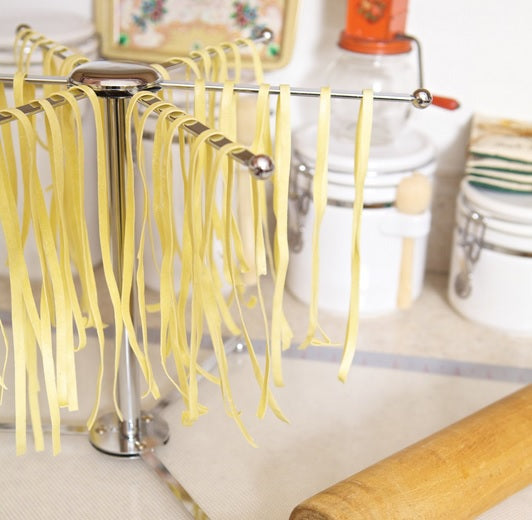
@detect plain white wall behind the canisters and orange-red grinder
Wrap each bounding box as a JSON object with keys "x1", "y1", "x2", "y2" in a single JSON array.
[{"x1": 5, "y1": 0, "x2": 532, "y2": 270}]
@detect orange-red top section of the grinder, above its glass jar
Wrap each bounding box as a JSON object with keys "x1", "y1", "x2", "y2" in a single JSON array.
[{"x1": 338, "y1": 0, "x2": 411, "y2": 54}]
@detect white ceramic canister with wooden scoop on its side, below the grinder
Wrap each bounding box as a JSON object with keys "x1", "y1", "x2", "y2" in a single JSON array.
[{"x1": 287, "y1": 127, "x2": 435, "y2": 316}]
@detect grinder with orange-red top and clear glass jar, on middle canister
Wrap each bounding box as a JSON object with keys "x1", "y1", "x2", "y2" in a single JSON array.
[{"x1": 327, "y1": 0, "x2": 421, "y2": 145}]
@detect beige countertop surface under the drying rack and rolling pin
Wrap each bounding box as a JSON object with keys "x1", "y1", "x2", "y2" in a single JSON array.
[{"x1": 0, "y1": 274, "x2": 532, "y2": 520}]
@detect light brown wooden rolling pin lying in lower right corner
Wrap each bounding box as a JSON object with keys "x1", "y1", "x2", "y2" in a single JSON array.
[{"x1": 290, "y1": 385, "x2": 532, "y2": 520}]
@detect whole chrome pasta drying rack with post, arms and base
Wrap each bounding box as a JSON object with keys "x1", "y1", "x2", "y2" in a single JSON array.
[{"x1": 0, "y1": 26, "x2": 432, "y2": 512}]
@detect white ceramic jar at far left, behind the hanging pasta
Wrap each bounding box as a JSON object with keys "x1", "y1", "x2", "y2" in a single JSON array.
[{"x1": 0, "y1": 8, "x2": 101, "y2": 280}]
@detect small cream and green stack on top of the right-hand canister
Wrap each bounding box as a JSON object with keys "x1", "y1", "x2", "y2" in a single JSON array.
[{"x1": 466, "y1": 117, "x2": 532, "y2": 194}]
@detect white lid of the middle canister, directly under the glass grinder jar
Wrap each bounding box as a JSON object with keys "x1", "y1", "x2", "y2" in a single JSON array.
[{"x1": 293, "y1": 125, "x2": 435, "y2": 179}]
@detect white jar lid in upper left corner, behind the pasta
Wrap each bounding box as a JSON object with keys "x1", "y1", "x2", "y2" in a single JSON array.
[{"x1": 0, "y1": 9, "x2": 95, "y2": 52}]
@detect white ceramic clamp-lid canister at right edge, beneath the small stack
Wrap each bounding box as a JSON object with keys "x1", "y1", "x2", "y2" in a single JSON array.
[{"x1": 448, "y1": 178, "x2": 532, "y2": 335}]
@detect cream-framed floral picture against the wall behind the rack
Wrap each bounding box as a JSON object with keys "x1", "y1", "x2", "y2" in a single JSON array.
[{"x1": 94, "y1": 0, "x2": 298, "y2": 69}]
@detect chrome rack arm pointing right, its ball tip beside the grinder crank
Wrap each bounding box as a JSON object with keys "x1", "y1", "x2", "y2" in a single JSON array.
[{"x1": 159, "y1": 80, "x2": 430, "y2": 108}]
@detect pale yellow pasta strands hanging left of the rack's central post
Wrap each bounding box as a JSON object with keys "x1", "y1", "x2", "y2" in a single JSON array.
[{"x1": 0, "y1": 30, "x2": 104, "y2": 453}]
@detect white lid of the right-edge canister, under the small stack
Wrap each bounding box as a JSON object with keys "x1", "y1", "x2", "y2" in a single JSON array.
[{"x1": 460, "y1": 178, "x2": 532, "y2": 224}]
